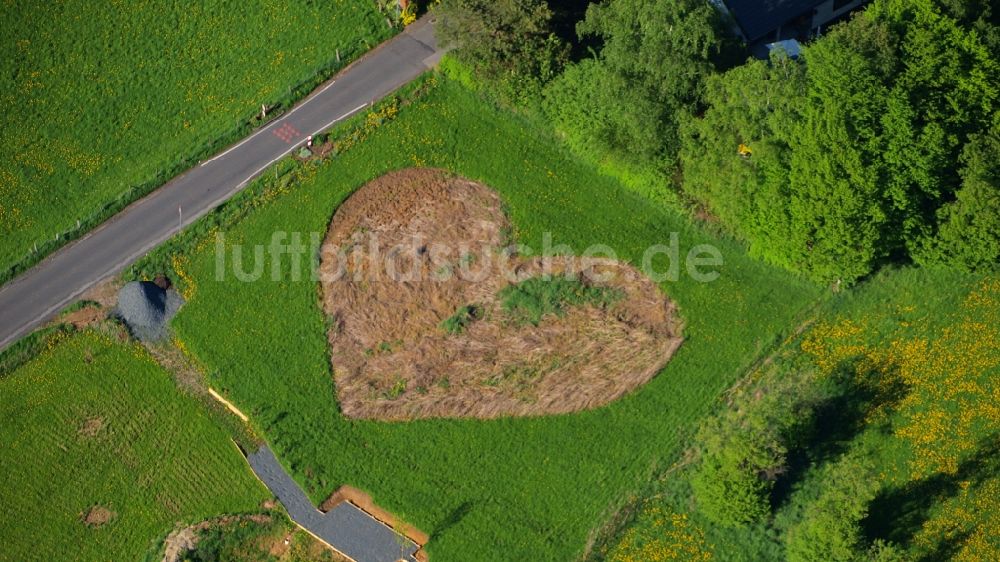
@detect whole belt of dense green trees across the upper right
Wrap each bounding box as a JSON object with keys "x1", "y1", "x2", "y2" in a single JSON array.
[{"x1": 440, "y1": 0, "x2": 1000, "y2": 286}]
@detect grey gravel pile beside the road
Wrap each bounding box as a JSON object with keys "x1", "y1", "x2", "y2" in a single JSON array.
[{"x1": 115, "y1": 281, "x2": 184, "y2": 341}]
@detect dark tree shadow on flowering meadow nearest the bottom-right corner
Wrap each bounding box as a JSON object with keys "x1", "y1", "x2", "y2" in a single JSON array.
[{"x1": 861, "y1": 434, "x2": 1000, "y2": 561}]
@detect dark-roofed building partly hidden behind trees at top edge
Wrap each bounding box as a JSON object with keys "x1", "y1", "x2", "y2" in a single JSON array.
[{"x1": 710, "y1": 0, "x2": 868, "y2": 46}]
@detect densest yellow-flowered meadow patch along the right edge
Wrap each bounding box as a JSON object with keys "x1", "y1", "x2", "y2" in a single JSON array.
[{"x1": 802, "y1": 277, "x2": 1000, "y2": 562}]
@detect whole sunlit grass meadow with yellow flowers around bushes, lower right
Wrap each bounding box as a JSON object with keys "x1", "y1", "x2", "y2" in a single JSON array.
[{"x1": 607, "y1": 268, "x2": 1000, "y2": 562}]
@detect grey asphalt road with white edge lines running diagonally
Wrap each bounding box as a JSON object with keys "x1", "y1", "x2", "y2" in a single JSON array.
[{"x1": 0, "y1": 18, "x2": 442, "y2": 349}]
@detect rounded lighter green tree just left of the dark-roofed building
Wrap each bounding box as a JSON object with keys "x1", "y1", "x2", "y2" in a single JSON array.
[{"x1": 544, "y1": 0, "x2": 726, "y2": 170}]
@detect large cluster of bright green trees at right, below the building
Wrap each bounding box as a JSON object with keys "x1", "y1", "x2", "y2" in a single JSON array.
[{"x1": 680, "y1": 0, "x2": 1000, "y2": 282}]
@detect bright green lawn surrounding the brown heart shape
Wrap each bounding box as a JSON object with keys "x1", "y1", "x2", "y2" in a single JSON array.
[{"x1": 145, "y1": 78, "x2": 822, "y2": 562}]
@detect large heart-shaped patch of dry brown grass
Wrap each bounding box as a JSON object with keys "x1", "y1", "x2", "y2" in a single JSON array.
[{"x1": 320, "y1": 169, "x2": 681, "y2": 420}]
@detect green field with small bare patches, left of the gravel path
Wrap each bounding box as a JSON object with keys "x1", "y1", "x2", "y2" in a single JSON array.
[{"x1": 0, "y1": 332, "x2": 270, "y2": 561}]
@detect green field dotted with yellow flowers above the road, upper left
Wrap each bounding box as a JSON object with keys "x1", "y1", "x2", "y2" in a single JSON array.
[{"x1": 0, "y1": 0, "x2": 392, "y2": 281}]
